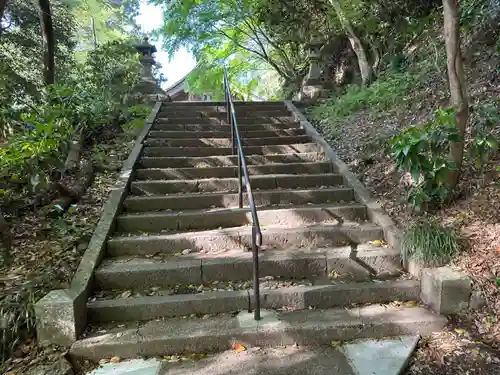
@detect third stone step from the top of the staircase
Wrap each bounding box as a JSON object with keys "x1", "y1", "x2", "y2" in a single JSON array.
[{"x1": 156, "y1": 116, "x2": 297, "y2": 126}]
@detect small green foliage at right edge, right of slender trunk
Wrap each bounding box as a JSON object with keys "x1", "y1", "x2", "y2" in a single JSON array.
[{"x1": 469, "y1": 99, "x2": 500, "y2": 168}]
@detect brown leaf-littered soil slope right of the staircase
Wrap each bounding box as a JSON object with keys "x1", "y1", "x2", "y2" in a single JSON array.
[{"x1": 304, "y1": 34, "x2": 500, "y2": 375}]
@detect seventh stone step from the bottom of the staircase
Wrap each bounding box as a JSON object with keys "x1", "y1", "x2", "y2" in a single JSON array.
[{"x1": 130, "y1": 173, "x2": 343, "y2": 195}]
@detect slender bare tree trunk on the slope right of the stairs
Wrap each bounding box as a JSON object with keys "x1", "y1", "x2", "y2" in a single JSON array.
[{"x1": 443, "y1": 0, "x2": 469, "y2": 188}]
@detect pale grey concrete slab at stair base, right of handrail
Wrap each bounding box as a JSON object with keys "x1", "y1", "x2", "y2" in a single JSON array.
[{"x1": 343, "y1": 335, "x2": 420, "y2": 375}]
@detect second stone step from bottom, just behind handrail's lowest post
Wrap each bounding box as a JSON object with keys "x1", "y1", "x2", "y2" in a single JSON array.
[{"x1": 87, "y1": 280, "x2": 420, "y2": 322}]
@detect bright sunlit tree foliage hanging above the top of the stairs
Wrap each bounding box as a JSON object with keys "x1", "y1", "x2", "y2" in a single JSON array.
[{"x1": 153, "y1": 0, "x2": 307, "y2": 98}]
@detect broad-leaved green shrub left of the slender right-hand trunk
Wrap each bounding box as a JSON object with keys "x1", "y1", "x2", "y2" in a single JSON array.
[{"x1": 391, "y1": 109, "x2": 459, "y2": 210}]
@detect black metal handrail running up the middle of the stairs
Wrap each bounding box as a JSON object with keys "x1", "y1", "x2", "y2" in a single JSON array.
[{"x1": 224, "y1": 67, "x2": 262, "y2": 320}]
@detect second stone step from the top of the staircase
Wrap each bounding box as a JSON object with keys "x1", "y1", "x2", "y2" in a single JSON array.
[{"x1": 157, "y1": 107, "x2": 290, "y2": 119}]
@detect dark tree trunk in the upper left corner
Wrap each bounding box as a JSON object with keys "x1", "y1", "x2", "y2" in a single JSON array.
[{"x1": 38, "y1": 0, "x2": 56, "y2": 85}]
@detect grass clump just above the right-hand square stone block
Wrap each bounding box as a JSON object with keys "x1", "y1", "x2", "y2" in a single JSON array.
[{"x1": 401, "y1": 220, "x2": 463, "y2": 267}]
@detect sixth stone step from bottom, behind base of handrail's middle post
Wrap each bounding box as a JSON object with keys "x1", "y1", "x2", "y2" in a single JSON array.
[{"x1": 123, "y1": 187, "x2": 354, "y2": 212}]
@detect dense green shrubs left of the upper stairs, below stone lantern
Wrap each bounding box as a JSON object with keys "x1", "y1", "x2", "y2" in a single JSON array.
[{"x1": 0, "y1": 42, "x2": 145, "y2": 204}]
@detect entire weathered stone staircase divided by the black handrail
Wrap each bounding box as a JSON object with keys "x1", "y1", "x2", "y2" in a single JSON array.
[{"x1": 71, "y1": 102, "x2": 443, "y2": 360}]
